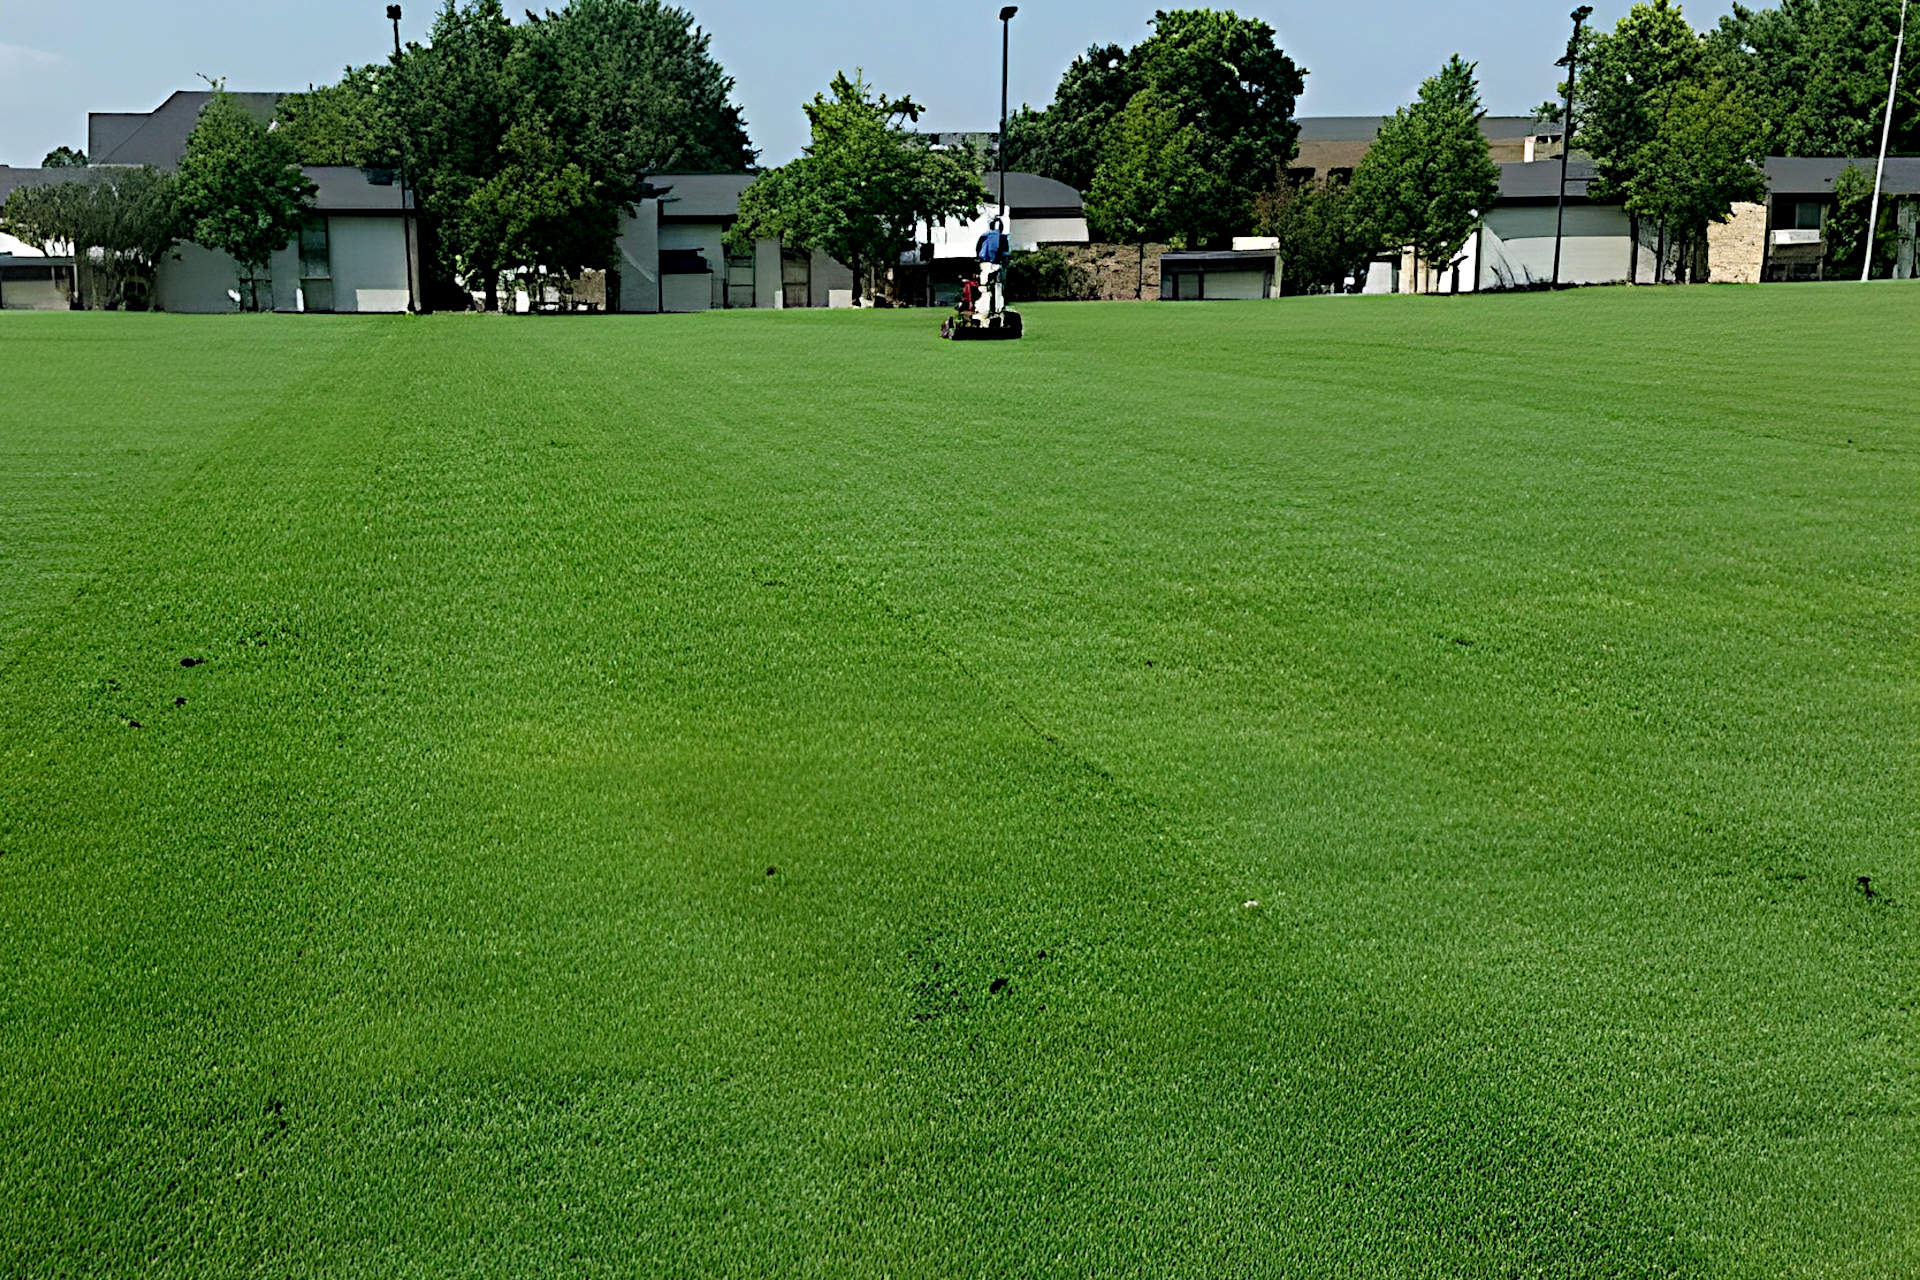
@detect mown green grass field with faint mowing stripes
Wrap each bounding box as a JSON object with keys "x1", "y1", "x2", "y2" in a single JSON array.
[{"x1": 0, "y1": 286, "x2": 1920, "y2": 1280}]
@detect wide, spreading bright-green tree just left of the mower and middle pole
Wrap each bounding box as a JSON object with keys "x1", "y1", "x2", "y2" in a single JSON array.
[{"x1": 728, "y1": 71, "x2": 987, "y2": 301}]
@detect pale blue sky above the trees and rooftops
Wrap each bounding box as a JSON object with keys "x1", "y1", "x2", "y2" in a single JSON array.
[{"x1": 0, "y1": 0, "x2": 1728, "y2": 165}]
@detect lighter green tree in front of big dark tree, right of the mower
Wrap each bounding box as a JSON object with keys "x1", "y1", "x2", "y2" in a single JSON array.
[{"x1": 1087, "y1": 88, "x2": 1229, "y2": 248}]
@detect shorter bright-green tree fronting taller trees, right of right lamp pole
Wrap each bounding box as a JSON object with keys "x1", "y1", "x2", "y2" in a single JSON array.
[{"x1": 1622, "y1": 79, "x2": 1766, "y2": 274}]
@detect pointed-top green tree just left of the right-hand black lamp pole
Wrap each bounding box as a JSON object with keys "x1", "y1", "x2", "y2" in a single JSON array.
[{"x1": 1352, "y1": 54, "x2": 1500, "y2": 289}]
